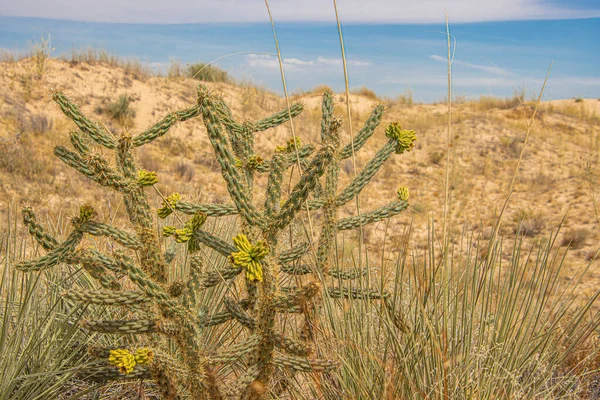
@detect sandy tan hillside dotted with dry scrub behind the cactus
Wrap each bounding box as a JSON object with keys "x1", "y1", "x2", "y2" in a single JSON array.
[{"x1": 0, "y1": 59, "x2": 600, "y2": 279}]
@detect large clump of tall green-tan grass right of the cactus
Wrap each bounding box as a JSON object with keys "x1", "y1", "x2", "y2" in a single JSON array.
[{"x1": 316, "y1": 227, "x2": 599, "y2": 399}]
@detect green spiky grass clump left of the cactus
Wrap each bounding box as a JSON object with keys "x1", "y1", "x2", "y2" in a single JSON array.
[{"x1": 0, "y1": 208, "x2": 90, "y2": 400}]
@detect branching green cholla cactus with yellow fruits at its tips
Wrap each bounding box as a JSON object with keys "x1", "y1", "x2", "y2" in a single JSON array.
[{"x1": 18, "y1": 86, "x2": 416, "y2": 399}]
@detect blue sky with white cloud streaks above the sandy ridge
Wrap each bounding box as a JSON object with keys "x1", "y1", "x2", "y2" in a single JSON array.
[{"x1": 0, "y1": 0, "x2": 600, "y2": 101}]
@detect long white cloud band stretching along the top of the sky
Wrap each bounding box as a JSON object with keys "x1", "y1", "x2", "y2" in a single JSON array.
[{"x1": 0, "y1": 0, "x2": 600, "y2": 23}]
